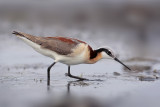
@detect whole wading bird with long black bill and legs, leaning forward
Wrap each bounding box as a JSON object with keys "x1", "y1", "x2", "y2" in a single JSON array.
[{"x1": 13, "y1": 31, "x2": 131, "y2": 85}]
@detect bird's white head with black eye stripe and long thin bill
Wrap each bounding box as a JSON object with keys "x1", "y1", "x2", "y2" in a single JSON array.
[{"x1": 97, "y1": 48, "x2": 131, "y2": 70}]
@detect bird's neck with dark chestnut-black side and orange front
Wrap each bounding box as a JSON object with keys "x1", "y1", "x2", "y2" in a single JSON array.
[{"x1": 89, "y1": 49, "x2": 102, "y2": 63}]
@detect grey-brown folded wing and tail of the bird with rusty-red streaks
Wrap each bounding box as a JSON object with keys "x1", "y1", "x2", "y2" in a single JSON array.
[{"x1": 13, "y1": 31, "x2": 80, "y2": 55}]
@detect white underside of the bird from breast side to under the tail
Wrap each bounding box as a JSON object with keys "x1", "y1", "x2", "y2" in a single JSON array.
[{"x1": 18, "y1": 36, "x2": 87, "y2": 65}]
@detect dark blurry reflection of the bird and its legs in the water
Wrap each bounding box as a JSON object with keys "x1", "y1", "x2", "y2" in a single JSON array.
[{"x1": 38, "y1": 81, "x2": 104, "y2": 107}]
